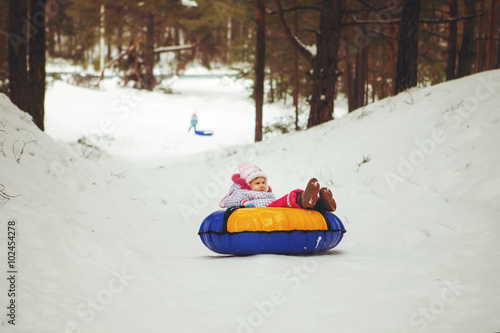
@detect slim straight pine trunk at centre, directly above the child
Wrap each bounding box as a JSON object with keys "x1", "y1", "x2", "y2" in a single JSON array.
[{"x1": 254, "y1": 0, "x2": 266, "y2": 142}]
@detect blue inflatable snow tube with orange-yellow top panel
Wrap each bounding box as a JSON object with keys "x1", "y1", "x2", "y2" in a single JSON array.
[{"x1": 198, "y1": 207, "x2": 346, "y2": 255}]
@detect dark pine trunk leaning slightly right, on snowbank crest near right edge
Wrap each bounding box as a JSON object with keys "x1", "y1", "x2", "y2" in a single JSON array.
[{"x1": 457, "y1": 0, "x2": 475, "y2": 78}]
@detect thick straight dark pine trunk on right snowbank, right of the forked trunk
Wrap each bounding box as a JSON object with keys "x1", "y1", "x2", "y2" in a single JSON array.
[{"x1": 394, "y1": 0, "x2": 420, "y2": 94}]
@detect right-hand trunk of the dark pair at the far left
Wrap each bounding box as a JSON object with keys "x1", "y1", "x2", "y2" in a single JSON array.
[{"x1": 28, "y1": 0, "x2": 47, "y2": 131}]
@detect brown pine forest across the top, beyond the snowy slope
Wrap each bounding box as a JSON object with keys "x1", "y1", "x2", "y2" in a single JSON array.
[{"x1": 0, "y1": 0, "x2": 500, "y2": 141}]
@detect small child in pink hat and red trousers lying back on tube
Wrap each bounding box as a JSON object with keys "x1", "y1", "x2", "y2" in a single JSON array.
[{"x1": 219, "y1": 162, "x2": 337, "y2": 212}]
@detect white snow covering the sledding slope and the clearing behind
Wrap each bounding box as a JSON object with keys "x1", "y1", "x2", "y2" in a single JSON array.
[{"x1": 0, "y1": 71, "x2": 500, "y2": 333}]
